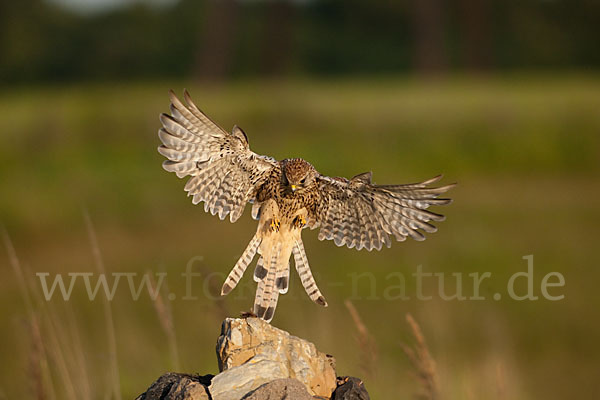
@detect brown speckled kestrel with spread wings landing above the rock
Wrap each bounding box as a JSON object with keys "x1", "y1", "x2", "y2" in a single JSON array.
[{"x1": 158, "y1": 91, "x2": 454, "y2": 322}]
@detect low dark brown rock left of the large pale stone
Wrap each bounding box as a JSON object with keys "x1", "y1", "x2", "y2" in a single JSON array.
[{"x1": 136, "y1": 372, "x2": 213, "y2": 400}]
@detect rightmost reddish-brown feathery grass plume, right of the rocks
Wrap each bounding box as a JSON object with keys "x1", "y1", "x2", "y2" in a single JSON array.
[{"x1": 401, "y1": 314, "x2": 440, "y2": 400}]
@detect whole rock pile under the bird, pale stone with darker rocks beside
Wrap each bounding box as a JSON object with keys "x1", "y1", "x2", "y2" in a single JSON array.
[{"x1": 136, "y1": 318, "x2": 369, "y2": 400}]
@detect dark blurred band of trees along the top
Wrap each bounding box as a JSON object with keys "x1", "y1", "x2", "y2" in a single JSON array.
[{"x1": 0, "y1": 0, "x2": 600, "y2": 84}]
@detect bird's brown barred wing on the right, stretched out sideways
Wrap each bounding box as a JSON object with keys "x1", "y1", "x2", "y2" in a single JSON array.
[{"x1": 309, "y1": 172, "x2": 454, "y2": 251}]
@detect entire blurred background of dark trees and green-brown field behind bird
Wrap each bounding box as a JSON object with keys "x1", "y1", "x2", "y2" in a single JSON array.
[{"x1": 0, "y1": 0, "x2": 600, "y2": 399}]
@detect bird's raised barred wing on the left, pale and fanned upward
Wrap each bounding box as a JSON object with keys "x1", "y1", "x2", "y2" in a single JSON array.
[{"x1": 158, "y1": 91, "x2": 278, "y2": 222}]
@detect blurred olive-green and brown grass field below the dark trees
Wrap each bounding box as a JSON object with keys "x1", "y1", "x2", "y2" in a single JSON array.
[{"x1": 0, "y1": 76, "x2": 600, "y2": 399}]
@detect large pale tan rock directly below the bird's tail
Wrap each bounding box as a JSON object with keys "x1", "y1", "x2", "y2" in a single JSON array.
[{"x1": 216, "y1": 318, "x2": 336, "y2": 400}]
